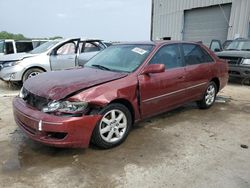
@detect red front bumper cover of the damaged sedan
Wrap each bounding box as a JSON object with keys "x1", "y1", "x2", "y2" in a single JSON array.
[{"x1": 13, "y1": 97, "x2": 101, "y2": 148}]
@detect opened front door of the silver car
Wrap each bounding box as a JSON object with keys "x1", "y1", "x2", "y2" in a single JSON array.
[{"x1": 50, "y1": 39, "x2": 80, "y2": 70}]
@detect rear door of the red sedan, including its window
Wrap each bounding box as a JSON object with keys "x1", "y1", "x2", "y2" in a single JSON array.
[{"x1": 182, "y1": 44, "x2": 214, "y2": 100}]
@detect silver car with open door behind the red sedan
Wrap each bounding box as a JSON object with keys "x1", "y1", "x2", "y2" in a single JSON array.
[{"x1": 0, "y1": 38, "x2": 106, "y2": 82}]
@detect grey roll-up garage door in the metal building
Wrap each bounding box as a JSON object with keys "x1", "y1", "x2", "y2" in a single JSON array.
[{"x1": 183, "y1": 4, "x2": 231, "y2": 46}]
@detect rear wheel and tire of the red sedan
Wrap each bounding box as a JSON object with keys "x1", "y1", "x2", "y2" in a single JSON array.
[{"x1": 197, "y1": 81, "x2": 218, "y2": 109}]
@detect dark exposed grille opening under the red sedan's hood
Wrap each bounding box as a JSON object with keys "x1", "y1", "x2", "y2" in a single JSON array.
[{"x1": 24, "y1": 90, "x2": 49, "y2": 110}]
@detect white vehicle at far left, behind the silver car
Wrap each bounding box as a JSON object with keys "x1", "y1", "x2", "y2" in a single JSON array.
[{"x1": 0, "y1": 39, "x2": 49, "y2": 55}]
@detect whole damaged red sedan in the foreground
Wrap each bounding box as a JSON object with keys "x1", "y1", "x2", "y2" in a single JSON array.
[{"x1": 13, "y1": 41, "x2": 228, "y2": 148}]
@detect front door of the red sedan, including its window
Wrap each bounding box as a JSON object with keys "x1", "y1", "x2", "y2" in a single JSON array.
[{"x1": 138, "y1": 44, "x2": 186, "y2": 118}]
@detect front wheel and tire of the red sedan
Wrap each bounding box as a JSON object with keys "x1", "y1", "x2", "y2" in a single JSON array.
[{"x1": 91, "y1": 103, "x2": 132, "y2": 149}]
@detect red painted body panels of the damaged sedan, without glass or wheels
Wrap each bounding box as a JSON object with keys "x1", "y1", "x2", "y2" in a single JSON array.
[{"x1": 13, "y1": 41, "x2": 228, "y2": 147}]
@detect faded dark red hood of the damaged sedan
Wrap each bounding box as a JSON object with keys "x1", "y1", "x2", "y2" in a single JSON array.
[{"x1": 24, "y1": 67, "x2": 127, "y2": 100}]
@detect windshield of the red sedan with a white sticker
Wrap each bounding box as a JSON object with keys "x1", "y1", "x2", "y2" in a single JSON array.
[{"x1": 85, "y1": 44, "x2": 154, "y2": 72}]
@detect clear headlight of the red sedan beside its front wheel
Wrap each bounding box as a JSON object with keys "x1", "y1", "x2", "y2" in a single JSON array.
[{"x1": 42, "y1": 101, "x2": 88, "y2": 114}]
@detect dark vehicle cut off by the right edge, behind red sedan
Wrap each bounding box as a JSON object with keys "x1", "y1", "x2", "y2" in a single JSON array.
[{"x1": 211, "y1": 39, "x2": 250, "y2": 78}]
